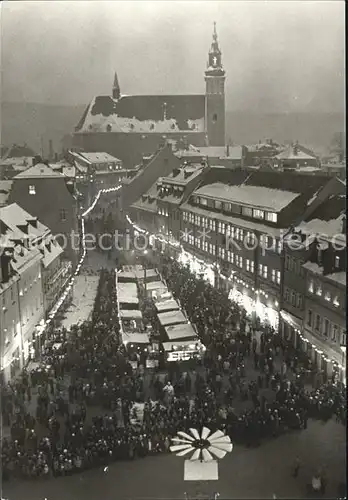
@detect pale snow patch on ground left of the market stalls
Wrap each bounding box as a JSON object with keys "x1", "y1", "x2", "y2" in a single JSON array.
[{"x1": 61, "y1": 275, "x2": 99, "y2": 329}]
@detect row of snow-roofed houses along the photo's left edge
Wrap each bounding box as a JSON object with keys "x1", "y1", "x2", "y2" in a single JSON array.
[{"x1": 0, "y1": 203, "x2": 71, "y2": 379}]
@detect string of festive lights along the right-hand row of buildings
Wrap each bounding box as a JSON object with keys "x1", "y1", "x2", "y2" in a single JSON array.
[{"x1": 126, "y1": 215, "x2": 345, "y2": 376}]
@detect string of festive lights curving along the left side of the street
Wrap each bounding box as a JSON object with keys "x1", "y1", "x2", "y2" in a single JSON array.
[{"x1": 0, "y1": 184, "x2": 122, "y2": 371}]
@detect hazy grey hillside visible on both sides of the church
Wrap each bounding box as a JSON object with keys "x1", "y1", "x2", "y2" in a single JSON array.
[{"x1": 0, "y1": 103, "x2": 344, "y2": 154}]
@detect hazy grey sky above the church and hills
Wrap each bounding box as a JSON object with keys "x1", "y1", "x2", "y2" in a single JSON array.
[{"x1": 1, "y1": 0, "x2": 345, "y2": 112}]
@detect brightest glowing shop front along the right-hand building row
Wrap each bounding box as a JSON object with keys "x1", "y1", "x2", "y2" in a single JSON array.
[{"x1": 229, "y1": 287, "x2": 279, "y2": 330}]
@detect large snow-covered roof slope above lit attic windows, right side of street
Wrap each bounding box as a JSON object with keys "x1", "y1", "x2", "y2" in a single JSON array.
[{"x1": 194, "y1": 182, "x2": 300, "y2": 212}]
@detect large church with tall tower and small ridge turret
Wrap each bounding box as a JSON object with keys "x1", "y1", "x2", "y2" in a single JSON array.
[{"x1": 73, "y1": 23, "x2": 226, "y2": 168}]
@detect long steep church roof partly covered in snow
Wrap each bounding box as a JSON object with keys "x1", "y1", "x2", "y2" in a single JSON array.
[{"x1": 75, "y1": 95, "x2": 205, "y2": 134}]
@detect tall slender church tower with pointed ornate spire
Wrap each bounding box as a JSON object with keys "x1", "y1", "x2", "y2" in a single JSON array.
[{"x1": 205, "y1": 23, "x2": 226, "y2": 146}]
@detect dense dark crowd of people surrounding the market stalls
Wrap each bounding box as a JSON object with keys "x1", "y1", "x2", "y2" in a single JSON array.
[{"x1": 2, "y1": 255, "x2": 346, "y2": 488}]
